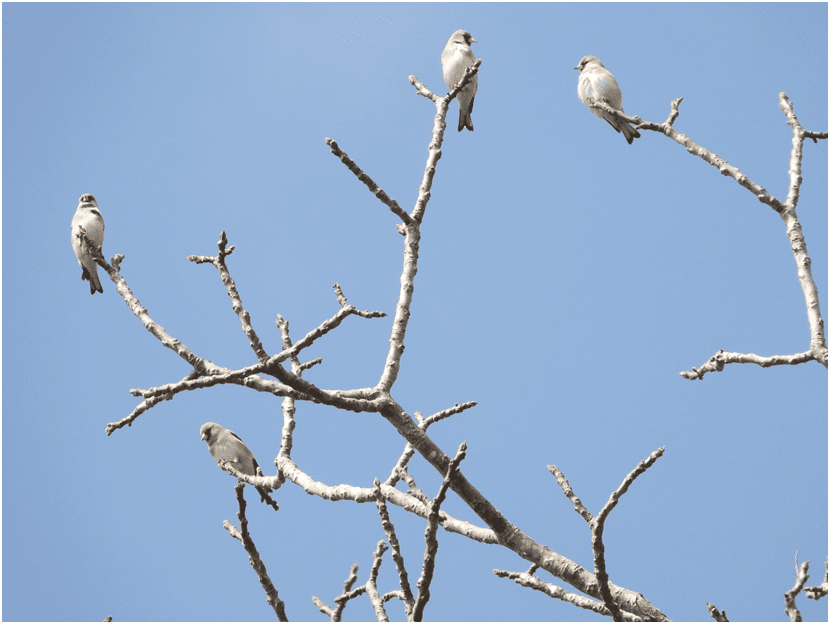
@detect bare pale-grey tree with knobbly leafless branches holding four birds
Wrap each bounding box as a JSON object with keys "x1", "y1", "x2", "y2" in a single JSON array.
[{"x1": 76, "y1": 50, "x2": 828, "y2": 621}]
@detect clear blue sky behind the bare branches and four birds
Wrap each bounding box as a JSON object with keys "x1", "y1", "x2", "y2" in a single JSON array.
[{"x1": 2, "y1": 3, "x2": 828, "y2": 621}]
